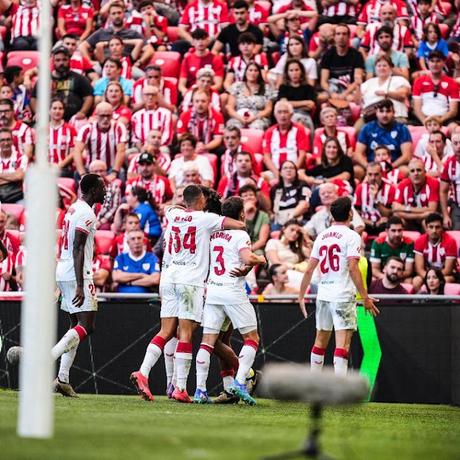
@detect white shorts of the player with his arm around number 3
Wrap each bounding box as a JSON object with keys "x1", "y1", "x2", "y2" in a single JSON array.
[{"x1": 160, "y1": 283, "x2": 204, "y2": 323}]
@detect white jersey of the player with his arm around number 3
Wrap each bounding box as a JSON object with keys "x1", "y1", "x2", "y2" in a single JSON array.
[{"x1": 160, "y1": 208, "x2": 225, "y2": 287}]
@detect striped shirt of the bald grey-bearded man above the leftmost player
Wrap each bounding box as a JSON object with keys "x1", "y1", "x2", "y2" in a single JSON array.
[{"x1": 76, "y1": 120, "x2": 128, "y2": 170}]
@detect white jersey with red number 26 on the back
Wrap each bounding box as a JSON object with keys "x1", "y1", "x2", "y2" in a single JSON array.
[{"x1": 311, "y1": 224, "x2": 361, "y2": 302}]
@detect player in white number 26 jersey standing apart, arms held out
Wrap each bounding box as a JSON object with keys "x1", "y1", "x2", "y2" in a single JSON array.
[{"x1": 299, "y1": 197, "x2": 379, "y2": 375}]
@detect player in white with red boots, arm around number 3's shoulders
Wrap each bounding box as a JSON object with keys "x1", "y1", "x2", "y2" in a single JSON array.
[{"x1": 131, "y1": 185, "x2": 245, "y2": 402}]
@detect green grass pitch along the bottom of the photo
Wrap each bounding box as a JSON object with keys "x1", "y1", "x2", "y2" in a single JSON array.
[{"x1": 0, "y1": 390, "x2": 460, "y2": 460}]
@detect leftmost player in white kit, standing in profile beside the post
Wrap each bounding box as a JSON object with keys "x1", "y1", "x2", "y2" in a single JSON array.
[{"x1": 52, "y1": 174, "x2": 106, "y2": 397}]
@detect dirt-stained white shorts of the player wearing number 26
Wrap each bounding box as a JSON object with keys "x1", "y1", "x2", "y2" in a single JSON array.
[{"x1": 316, "y1": 300, "x2": 356, "y2": 331}]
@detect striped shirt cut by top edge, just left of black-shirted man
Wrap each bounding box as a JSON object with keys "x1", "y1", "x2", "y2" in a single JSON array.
[{"x1": 180, "y1": 0, "x2": 228, "y2": 38}]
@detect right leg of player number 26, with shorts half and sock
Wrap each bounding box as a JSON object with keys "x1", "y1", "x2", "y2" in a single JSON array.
[{"x1": 332, "y1": 301, "x2": 357, "y2": 375}]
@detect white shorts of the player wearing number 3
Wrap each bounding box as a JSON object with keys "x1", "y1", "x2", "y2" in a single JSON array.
[{"x1": 202, "y1": 300, "x2": 257, "y2": 334}]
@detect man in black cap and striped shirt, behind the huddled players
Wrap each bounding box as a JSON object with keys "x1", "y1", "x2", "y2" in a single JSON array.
[{"x1": 126, "y1": 152, "x2": 173, "y2": 214}]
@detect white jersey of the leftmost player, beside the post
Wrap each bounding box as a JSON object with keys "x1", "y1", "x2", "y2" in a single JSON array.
[{"x1": 56, "y1": 200, "x2": 96, "y2": 281}]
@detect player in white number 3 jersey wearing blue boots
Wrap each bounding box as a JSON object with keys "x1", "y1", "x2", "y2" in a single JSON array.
[{"x1": 194, "y1": 197, "x2": 266, "y2": 405}]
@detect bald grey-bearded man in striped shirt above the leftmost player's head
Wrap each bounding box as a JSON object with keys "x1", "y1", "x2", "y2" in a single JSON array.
[{"x1": 74, "y1": 102, "x2": 128, "y2": 182}]
